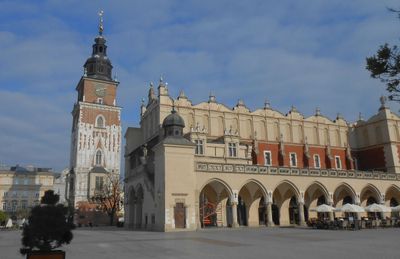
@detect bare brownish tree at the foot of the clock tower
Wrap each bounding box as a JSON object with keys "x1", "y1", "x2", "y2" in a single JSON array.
[{"x1": 91, "y1": 174, "x2": 123, "y2": 226}]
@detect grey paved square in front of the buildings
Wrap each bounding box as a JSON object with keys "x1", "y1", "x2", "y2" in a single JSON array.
[{"x1": 0, "y1": 227, "x2": 400, "y2": 259}]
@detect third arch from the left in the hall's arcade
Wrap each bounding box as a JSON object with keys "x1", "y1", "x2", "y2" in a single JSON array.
[{"x1": 272, "y1": 180, "x2": 302, "y2": 226}]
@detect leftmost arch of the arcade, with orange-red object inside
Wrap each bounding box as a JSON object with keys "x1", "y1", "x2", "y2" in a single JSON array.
[{"x1": 199, "y1": 178, "x2": 233, "y2": 227}]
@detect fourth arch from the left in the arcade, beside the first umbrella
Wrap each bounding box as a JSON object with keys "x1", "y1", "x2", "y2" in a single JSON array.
[{"x1": 304, "y1": 181, "x2": 331, "y2": 220}]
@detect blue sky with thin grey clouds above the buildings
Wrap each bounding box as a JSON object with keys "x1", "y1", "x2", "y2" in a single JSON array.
[{"x1": 0, "y1": 0, "x2": 400, "y2": 173}]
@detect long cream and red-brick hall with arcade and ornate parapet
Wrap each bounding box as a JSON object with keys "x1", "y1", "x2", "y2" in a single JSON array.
[{"x1": 125, "y1": 80, "x2": 400, "y2": 231}]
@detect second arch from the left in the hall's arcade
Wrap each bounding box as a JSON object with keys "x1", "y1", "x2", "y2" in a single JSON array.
[{"x1": 237, "y1": 179, "x2": 268, "y2": 226}]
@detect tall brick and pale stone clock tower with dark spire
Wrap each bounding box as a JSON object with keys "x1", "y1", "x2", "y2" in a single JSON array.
[{"x1": 67, "y1": 12, "x2": 121, "y2": 207}]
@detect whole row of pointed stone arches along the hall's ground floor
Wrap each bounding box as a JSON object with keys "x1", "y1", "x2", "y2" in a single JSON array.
[{"x1": 199, "y1": 178, "x2": 400, "y2": 227}]
